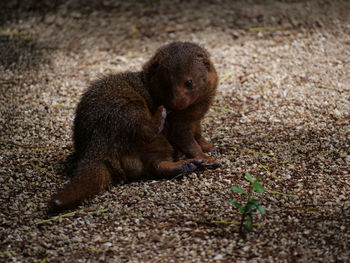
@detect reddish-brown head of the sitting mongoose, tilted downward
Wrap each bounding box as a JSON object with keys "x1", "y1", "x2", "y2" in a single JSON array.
[{"x1": 143, "y1": 42, "x2": 217, "y2": 110}]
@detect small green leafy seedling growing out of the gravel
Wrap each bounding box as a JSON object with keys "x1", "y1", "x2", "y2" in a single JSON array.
[{"x1": 231, "y1": 173, "x2": 265, "y2": 236}]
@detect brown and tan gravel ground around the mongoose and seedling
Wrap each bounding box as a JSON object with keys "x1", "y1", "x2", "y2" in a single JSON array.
[{"x1": 0, "y1": 0, "x2": 350, "y2": 262}]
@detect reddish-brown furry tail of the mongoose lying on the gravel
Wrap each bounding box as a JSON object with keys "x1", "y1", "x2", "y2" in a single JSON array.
[{"x1": 49, "y1": 162, "x2": 112, "y2": 213}]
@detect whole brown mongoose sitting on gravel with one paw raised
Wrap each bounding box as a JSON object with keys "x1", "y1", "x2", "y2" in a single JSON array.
[{"x1": 49, "y1": 42, "x2": 219, "y2": 212}]
